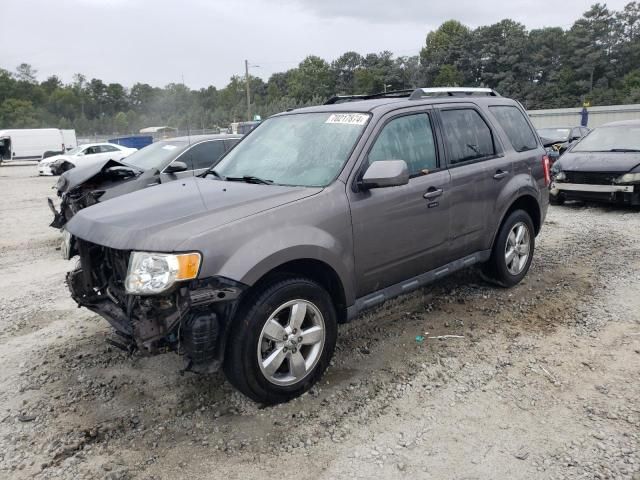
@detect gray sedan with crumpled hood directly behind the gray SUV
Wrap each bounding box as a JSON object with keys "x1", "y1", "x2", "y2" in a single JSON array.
[{"x1": 49, "y1": 135, "x2": 241, "y2": 228}]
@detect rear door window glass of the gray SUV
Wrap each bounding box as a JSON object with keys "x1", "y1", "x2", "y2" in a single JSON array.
[{"x1": 440, "y1": 108, "x2": 495, "y2": 165}]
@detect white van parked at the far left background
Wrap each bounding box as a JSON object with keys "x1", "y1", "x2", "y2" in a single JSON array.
[{"x1": 0, "y1": 128, "x2": 77, "y2": 164}]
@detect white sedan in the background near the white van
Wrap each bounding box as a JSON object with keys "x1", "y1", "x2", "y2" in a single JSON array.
[{"x1": 38, "y1": 143, "x2": 138, "y2": 175}]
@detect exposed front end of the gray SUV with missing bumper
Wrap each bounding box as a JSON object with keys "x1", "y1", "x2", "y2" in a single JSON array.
[{"x1": 67, "y1": 239, "x2": 245, "y2": 373}]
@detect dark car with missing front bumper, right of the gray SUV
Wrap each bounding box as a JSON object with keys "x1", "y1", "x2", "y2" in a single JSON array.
[{"x1": 550, "y1": 120, "x2": 640, "y2": 205}]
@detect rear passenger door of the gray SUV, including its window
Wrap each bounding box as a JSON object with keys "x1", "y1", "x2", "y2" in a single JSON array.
[{"x1": 438, "y1": 104, "x2": 513, "y2": 259}]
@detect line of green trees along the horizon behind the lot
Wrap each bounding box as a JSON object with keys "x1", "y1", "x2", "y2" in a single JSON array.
[{"x1": 0, "y1": 1, "x2": 640, "y2": 135}]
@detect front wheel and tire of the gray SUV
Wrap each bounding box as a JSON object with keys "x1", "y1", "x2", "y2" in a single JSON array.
[{"x1": 223, "y1": 277, "x2": 337, "y2": 404}]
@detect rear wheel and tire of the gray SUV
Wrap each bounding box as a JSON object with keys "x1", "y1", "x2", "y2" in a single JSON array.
[{"x1": 483, "y1": 210, "x2": 535, "y2": 288}]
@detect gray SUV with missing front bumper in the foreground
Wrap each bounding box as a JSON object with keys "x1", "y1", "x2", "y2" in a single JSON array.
[{"x1": 65, "y1": 88, "x2": 550, "y2": 403}]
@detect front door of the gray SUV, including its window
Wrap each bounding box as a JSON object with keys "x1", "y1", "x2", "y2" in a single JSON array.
[{"x1": 348, "y1": 109, "x2": 449, "y2": 297}]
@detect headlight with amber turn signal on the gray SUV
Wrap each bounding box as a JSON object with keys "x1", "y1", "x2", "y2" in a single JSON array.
[{"x1": 125, "y1": 252, "x2": 201, "y2": 295}]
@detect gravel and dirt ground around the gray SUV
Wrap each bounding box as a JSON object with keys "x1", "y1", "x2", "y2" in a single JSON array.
[{"x1": 0, "y1": 165, "x2": 640, "y2": 480}]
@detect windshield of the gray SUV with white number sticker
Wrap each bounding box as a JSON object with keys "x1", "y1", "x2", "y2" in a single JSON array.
[{"x1": 215, "y1": 113, "x2": 369, "y2": 187}]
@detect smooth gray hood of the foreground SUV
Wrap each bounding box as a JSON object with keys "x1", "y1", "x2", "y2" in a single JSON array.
[{"x1": 65, "y1": 177, "x2": 322, "y2": 252}]
